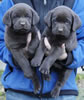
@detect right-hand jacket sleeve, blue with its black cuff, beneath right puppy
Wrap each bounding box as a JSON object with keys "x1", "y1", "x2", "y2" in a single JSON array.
[{"x1": 57, "y1": 27, "x2": 84, "y2": 69}]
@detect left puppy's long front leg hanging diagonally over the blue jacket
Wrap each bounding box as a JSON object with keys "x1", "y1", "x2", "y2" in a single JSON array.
[{"x1": 10, "y1": 49, "x2": 33, "y2": 78}]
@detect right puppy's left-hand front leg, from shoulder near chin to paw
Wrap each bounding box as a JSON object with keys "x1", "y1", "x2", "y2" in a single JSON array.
[{"x1": 31, "y1": 27, "x2": 50, "y2": 67}]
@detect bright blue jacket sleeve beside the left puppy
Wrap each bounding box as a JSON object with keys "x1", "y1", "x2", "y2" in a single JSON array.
[{"x1": 0, "y1": 0, "x2": 14, "y2": 67}]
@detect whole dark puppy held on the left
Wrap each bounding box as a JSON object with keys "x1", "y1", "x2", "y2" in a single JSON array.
[{"x1": 3, "y1": 3, "x2": 40, "y2": 93}]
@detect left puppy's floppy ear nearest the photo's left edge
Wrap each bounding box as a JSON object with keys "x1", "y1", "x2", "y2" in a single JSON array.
[{"x1": 3, "y1": 10, "x2": 11, "y2": 27}]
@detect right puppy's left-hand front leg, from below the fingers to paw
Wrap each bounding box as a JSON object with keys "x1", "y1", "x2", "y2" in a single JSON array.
[{"x1": 31, "y1": 39, "x2": 45, "y2": 67}]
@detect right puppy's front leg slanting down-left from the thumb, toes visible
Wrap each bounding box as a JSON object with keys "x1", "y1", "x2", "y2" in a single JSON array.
[{"x1": 39, "y1": 47, "x2": 63, "y2": 74}]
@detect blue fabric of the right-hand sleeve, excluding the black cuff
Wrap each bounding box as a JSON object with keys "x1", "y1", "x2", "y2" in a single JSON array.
[{"x1": 68, "y1": 36, "x2": 84, "y2": 68}]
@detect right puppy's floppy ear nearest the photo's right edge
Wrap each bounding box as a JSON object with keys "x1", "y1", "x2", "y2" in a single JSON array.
[{"x1": 72, "y1": 12, "x2": 81, "y2": 31}]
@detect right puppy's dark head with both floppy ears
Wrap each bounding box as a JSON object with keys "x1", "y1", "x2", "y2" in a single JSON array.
[{"x1": 44, "y1": 6, "x2": 81, "y2": 38}]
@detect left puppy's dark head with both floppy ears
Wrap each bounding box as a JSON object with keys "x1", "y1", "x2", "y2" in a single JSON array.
[{"x1": 3, "y1": 3, "x2": 39, "y2": 31}]
